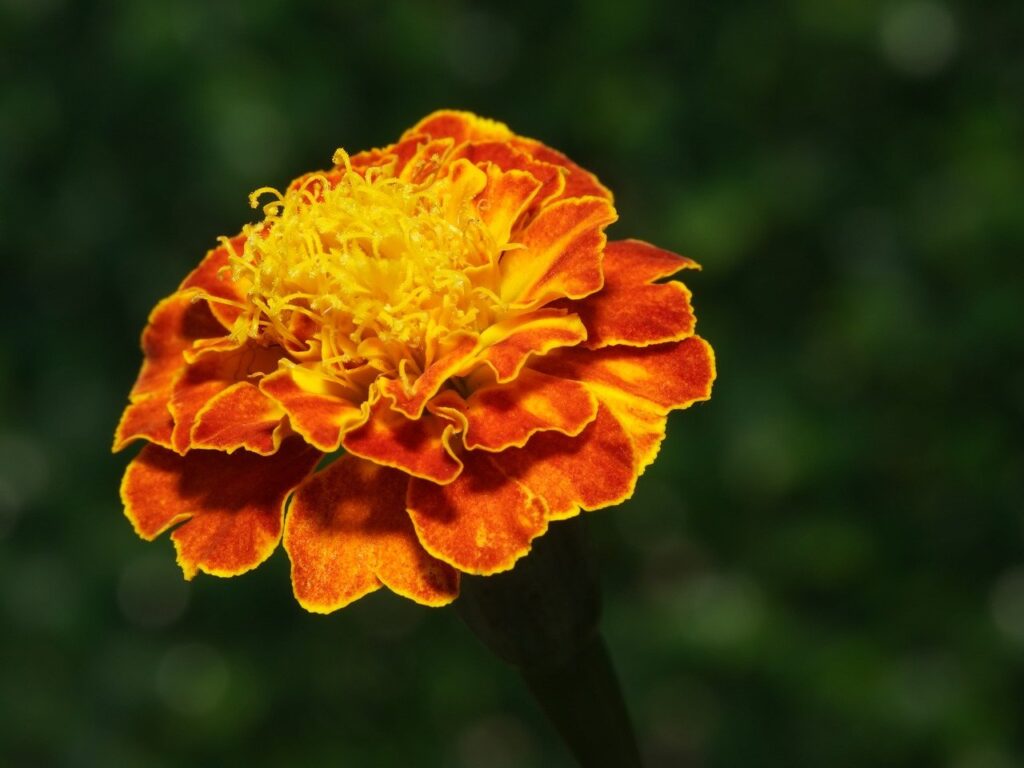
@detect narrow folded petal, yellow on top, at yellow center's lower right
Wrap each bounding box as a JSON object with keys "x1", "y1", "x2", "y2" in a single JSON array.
[{"x1": 473, "y1": 308, "x2": 587, "y2": 382}]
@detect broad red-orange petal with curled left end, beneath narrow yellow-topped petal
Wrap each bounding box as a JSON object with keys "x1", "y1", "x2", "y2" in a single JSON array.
[{"x1": 430, "y1": 369, "x2": 597, "y2": 452}]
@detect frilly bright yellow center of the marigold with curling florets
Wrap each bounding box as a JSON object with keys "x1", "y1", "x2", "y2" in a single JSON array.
[{"x1": 219, "y1": 150, "x2": 508, "y2": 381}]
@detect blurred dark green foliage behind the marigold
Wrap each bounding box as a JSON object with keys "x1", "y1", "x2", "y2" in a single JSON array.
[{"x1": 0, "y1": 0, "x2": 1024, "y2": 768}]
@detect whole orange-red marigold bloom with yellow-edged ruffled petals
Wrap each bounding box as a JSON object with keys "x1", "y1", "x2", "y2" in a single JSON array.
[{"x1": 114, "y1": 112, "x2": 715, "y2": 612}]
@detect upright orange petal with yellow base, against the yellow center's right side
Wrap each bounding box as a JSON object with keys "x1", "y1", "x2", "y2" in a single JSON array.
[{"x1": 501, "y1": 198, "x2": 616, "y2": 306}]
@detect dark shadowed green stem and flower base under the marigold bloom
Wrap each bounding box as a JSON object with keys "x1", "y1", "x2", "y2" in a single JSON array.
[{"x1": 456, "y1": 517, "x2": 641, "y2": 768}]
